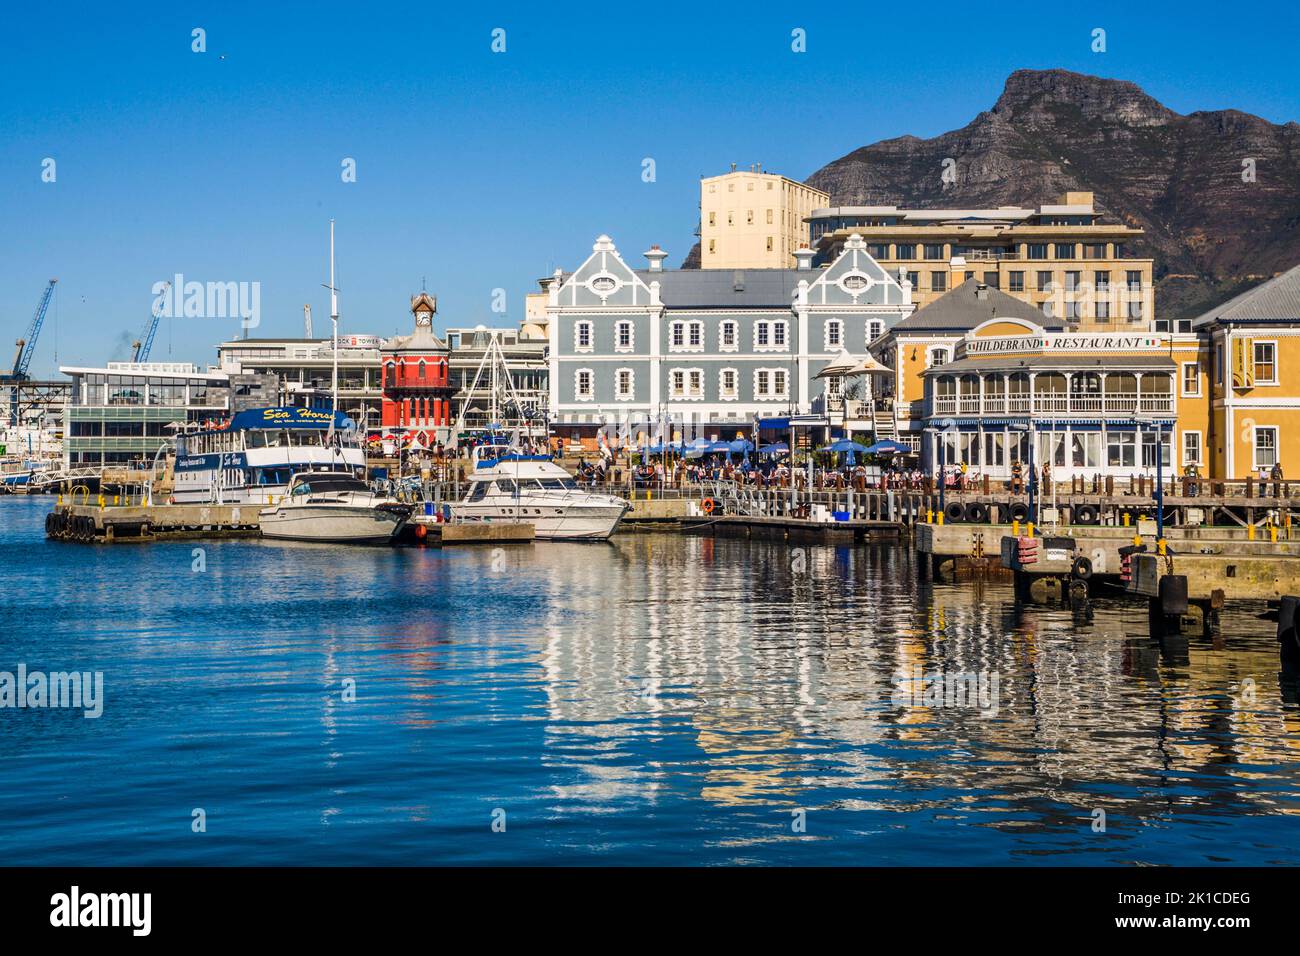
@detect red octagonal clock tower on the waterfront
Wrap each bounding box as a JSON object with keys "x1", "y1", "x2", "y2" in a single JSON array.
[{"x1": 380, "y1": 293, "x2": 452, "y2": 447}]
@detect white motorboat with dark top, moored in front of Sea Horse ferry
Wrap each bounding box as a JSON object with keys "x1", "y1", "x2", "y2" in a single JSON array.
[{"x1": 257, "y1": 471, "x2": 412, "y2": 544}]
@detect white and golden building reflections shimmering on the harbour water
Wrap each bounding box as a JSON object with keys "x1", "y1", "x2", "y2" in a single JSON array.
[{"x1": 528, "y1": 535, "x2": 1300, "y2": 827}]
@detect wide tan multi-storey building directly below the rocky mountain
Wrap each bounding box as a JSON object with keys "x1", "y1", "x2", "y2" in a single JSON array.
[{"x1": 807, "y1": 193, "x2": 1167, "y2": 332}]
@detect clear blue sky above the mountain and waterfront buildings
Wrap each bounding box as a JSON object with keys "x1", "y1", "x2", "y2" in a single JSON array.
[{"x1": 0, "y1": 3, "x2": 1300, "y2": 375}]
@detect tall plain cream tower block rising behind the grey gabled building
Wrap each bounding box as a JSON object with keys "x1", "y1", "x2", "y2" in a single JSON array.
[{"x1": 699, "y1": 164, "x2": 831, "y2": 269}]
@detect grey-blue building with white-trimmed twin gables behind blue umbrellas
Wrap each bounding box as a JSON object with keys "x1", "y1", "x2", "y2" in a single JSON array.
[{"x1": 546, "y1": 235, "x2": 913, "y2": 442}]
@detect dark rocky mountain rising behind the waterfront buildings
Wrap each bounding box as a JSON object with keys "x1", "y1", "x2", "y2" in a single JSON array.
[{"x1": 692, "y1": 70, "x2": 1300, "y2": 317}]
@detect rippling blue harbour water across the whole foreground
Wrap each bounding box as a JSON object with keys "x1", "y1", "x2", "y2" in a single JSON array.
[{"x1": 0, "y1": 498, "x2": 1300, "y2": 865}]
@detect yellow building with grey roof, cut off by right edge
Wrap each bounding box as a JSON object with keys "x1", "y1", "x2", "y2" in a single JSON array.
[{"x1": 1192, "y1": 265, "x2": 1300, "y2": 479}]
